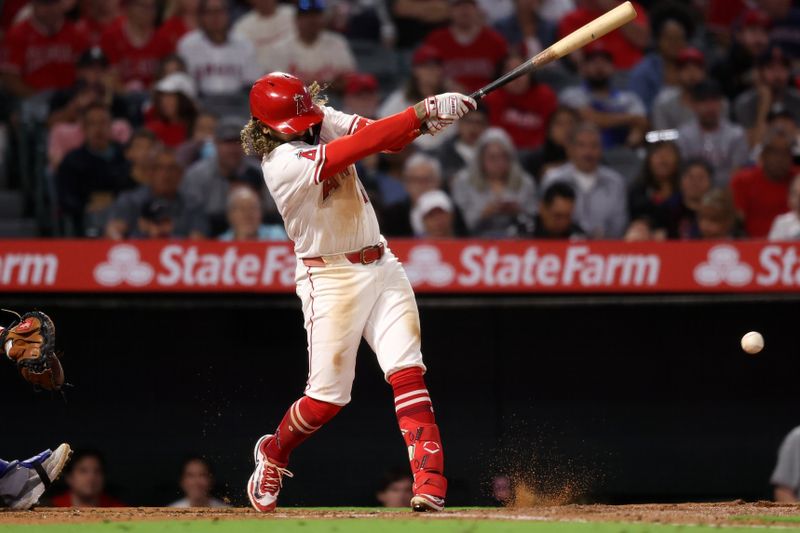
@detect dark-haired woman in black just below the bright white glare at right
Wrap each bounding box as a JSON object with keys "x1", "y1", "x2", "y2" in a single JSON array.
[{"x1": 628, "y1": 141, "x2": 681, "y2": 219}]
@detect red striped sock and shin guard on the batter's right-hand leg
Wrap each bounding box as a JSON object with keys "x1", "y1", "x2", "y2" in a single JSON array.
[{"x1": 389, "y1": 367, "x2": 447, "y2": 499}]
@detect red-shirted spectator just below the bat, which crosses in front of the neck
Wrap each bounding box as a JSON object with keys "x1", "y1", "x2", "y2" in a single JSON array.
[{"x1": 485, "y1": 53, "x2": 558, "y2": 151}]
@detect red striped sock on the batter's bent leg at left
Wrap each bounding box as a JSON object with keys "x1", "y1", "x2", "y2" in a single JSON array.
[{"x1": 264, "y1": 396, "x2": 342, "y2": 466}]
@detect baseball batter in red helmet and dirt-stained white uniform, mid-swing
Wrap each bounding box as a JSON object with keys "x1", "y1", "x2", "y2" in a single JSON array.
[{"x1": 242, "y1": 72, "x2": 476, "y2": 512}]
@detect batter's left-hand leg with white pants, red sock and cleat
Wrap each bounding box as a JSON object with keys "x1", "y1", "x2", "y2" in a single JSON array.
[{"x1": 248, "y1": 267, "x2": 373, "y2": 512}]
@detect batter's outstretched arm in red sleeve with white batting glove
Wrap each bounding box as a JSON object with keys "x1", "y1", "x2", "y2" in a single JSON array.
[{"x1": 316, "y1": 93, "x2": 477, "y2": 181}]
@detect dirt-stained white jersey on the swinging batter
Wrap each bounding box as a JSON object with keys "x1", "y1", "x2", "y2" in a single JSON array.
[{"x1": 261, "y1": 107, "x2": 381, "y2": 257}]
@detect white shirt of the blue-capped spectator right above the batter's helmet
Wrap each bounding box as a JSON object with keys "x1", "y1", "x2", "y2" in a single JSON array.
[{"x1": 275, "y1": 30, "x2": 356, "y2": 83}]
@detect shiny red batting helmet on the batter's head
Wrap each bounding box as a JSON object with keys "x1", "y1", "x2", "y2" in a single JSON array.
[{"x1": 250, "y1": 72, "x2": 325, "y2": 133}]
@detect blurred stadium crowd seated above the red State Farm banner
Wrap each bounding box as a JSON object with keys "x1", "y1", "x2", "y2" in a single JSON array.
[{"x1": 0, "y1": 0, "x2": 800, "y2": 241}]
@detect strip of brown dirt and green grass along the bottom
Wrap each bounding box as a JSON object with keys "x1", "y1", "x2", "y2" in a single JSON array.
[{"x1": 0, "y1": 501, "x2": 800, "y2": 533}]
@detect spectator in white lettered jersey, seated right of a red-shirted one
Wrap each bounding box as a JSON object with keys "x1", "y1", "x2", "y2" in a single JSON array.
[{"x1": 177, "y1": 0, "x2": 262, "y2": 102}]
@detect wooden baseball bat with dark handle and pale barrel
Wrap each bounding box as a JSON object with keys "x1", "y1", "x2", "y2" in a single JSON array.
[{"x1": 470, "y1": 2, "x2": 636, "y2": 100}]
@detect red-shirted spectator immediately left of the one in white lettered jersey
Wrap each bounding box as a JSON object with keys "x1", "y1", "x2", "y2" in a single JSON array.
[{"x1": 100, "y1": 0, "x2": 170, "y2": 92}]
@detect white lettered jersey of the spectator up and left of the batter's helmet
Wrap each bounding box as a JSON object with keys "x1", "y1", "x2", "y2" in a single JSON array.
[{"x1": 178, "y1": 30, "x2": 262, "y2": 96}]
